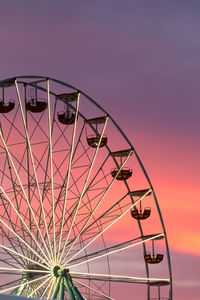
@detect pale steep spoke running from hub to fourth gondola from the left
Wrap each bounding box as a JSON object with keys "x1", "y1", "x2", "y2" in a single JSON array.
[{"x1": 59, "y1": 117, "x2": 108, "y2": 262}]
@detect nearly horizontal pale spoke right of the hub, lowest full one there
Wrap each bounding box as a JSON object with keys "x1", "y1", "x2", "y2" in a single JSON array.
[{"x1": 70, "y1": 272, "x2": 170, "y2": 284}]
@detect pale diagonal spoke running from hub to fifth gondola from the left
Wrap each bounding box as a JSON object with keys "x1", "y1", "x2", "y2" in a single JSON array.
[{"x1": 62, "y1": 151, "x2": 132, "y2": 262}]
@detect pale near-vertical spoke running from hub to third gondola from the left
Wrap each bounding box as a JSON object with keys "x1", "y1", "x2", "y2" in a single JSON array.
[{"x1": 57, "y1": 94, "x2": 80, "y2": 259}]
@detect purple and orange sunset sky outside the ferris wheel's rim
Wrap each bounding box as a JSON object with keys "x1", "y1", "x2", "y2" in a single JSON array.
[{"x1": 0, "y1": 0, "x2": 200, "y2": 300}]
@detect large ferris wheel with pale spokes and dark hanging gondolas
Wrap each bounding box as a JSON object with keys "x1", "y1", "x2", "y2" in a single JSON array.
[{"x1": 0, "y1": 76, "x2": 172, "y2": 300}]
